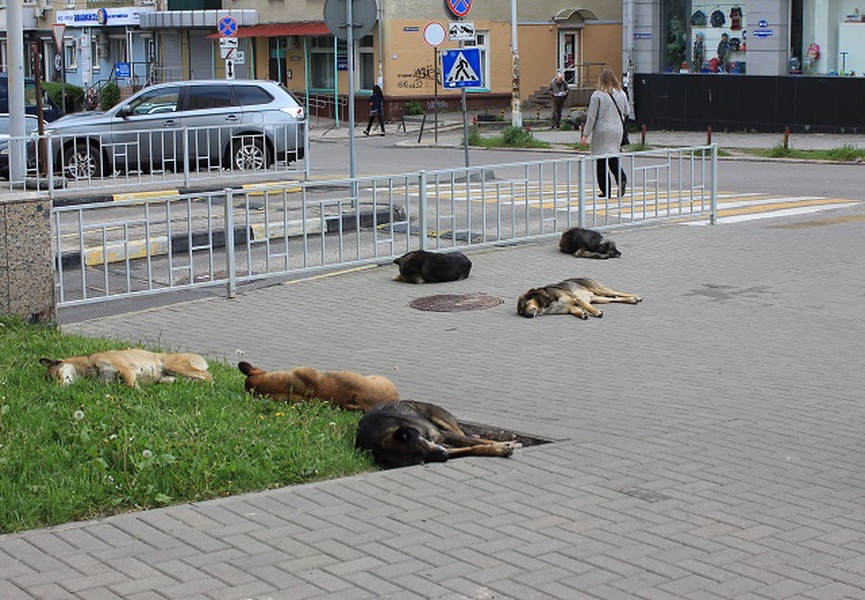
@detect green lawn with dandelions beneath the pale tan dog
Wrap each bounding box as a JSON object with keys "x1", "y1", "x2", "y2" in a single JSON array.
[{"x1": 0, "y1": 317, "x2": 375, "y2": 533}]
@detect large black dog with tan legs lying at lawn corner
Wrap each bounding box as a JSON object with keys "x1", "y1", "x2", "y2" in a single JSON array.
[{"x1": 354, "y1": 400, "x2": 520, "y2": 467}]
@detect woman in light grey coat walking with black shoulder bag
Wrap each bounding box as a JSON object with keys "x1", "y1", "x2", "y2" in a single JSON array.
[{"x1": 580, "y1": 69, "x2": 628, "y2": 198}]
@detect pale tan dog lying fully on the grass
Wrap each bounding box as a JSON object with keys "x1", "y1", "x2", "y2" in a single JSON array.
[{"x1": 39, "y1": 348, "x2": 211, "y2": 387}]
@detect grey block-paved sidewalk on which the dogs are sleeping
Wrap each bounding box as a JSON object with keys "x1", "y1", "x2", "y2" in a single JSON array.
[{"x1": 0, "y1": 206, "x2": 865, "y2": 600}]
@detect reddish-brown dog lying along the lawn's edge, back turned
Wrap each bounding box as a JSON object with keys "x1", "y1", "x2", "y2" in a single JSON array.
[{"x1": 237, "y1": 362, "x2": 399, "y2": 410}]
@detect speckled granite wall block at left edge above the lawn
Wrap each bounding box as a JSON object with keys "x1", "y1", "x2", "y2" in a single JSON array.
[{"x1": 0, "y1": 192, "x2": 55, "y2": 323}]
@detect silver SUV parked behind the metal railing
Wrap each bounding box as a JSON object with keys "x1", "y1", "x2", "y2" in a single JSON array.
[{"x1": 45, "y1": 80, "x2": 305, "y2": 179}]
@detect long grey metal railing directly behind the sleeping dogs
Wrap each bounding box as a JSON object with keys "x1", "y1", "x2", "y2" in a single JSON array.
[{"x1": 53, "y1": 146, "x2": 717, "y2": 306}]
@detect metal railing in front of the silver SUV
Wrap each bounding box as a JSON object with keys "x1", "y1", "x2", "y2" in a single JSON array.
[{"x1": 0, "y1": 119, "x2": 309, "y2": 199}]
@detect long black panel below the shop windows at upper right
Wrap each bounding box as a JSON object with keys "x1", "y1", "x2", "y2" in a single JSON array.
[{"x1": 634, "y1": 74, "x2": 865, "y2": 133}]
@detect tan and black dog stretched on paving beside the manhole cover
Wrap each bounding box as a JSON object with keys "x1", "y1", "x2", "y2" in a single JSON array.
[{"x1": 517, "y1": 277, "x2": 643, "y2": 319}]
